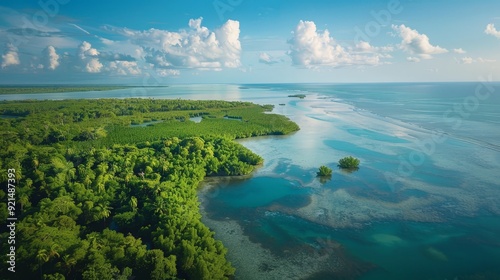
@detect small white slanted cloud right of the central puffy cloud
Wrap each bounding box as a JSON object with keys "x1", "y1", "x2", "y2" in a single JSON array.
[{"x1": 392, "y1": 24, "x2": 448, "y2": 59}]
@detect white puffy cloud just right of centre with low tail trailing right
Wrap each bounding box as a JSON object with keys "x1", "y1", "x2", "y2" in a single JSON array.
[{"x1": 288, "y1": 20, "x2": 382, "y2": 68}]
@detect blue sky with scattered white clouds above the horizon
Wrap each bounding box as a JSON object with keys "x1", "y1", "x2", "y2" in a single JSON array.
[{"x1": 0, "y1": 0, "x2": 500, "y2": 86}]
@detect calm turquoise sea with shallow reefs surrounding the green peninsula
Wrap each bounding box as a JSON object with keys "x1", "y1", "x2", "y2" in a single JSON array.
[{"x1": 0, "y1": 82, "x2": 500, "y2": 280}]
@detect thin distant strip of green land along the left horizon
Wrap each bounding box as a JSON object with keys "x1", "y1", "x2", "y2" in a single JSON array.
[{"x1": 0, "y1": 85, "x2": 166, "y2": 94}]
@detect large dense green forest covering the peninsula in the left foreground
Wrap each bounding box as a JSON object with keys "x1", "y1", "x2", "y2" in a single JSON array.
[{"x1": 0, "y1": 99, "x2": 298, "y2": 280}]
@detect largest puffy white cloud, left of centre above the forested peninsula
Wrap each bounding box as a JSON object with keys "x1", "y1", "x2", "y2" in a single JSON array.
[{"x1": 117, "y1": 18, "x2": 241, "y2": 70}]
